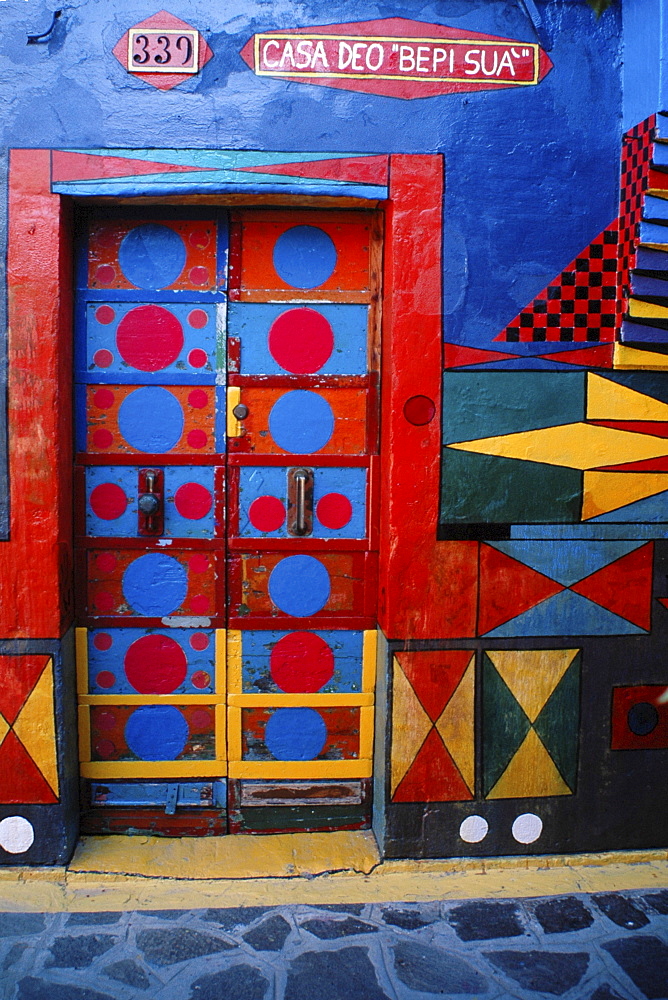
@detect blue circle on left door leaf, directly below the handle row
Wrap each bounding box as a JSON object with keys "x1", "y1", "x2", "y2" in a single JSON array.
[{"x1": 122, "y1": 552, "x2": 188, "y2": 618}]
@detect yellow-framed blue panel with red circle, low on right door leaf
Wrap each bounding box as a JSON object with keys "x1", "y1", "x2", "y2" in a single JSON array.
[{"x1": 241, "y1": 630, "x2": 363, "y2": 694}]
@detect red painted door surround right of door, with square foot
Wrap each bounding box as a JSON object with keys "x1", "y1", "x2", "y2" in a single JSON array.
[{"x1": 379, "y1": 155, "x2": 478, "y2": 639}]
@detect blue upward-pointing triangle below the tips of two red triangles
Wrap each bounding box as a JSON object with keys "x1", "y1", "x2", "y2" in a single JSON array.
[{"x1": 485, "y1": 590, "x2": 647, "y2": 639}]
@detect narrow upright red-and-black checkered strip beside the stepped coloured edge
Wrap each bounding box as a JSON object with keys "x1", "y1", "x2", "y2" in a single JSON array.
[{"x1": 617, "y1": 115, "x2": 656, "y2": 300}]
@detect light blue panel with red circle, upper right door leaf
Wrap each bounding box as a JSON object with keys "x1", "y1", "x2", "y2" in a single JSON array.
[{"x1": 227, "y1": 302, "x2": 368, "y2": 375}]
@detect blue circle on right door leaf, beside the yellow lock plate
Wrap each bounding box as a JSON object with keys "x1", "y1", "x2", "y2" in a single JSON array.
[{"x1": 269, "y1": 389, "x2": 334, "y2": 455}]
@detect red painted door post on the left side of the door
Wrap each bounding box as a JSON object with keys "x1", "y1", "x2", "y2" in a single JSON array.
[{"x1": 0, "y1": 149, "x2": 72, "y2": 638}]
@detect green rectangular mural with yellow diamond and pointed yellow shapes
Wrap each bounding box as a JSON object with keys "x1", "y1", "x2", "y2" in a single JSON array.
[{"x1": 441, "y1": 372, "x2": 668, "y2": 537}]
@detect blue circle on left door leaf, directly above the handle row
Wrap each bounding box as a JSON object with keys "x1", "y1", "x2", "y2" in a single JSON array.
[{"x1": 118, "y1": 385, "x2": 184, "y2": 453}]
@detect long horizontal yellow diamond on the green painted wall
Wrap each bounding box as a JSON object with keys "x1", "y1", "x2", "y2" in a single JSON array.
[{"x1": 448, "y1": 420, "x2": 668, "y2": 469}]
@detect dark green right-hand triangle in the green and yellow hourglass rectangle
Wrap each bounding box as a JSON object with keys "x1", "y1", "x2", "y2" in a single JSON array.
[{"x1": 533, "y1": 653, "x2": 582, "y2": 792}]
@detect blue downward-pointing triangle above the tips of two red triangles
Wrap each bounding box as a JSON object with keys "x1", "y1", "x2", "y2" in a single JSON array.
[{"x1": 490, "y1": 539, "x2": 640, "y2": 587}]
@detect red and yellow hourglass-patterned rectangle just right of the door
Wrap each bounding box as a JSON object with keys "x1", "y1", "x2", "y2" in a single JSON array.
[{"x1": 391, "y1": 649, "x2": 475, "y2": 802}]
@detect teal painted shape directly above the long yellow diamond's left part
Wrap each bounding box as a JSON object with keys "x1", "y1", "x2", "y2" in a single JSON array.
[{"x1": 443, "y1": 371, "x2": 586, "y2": 444}]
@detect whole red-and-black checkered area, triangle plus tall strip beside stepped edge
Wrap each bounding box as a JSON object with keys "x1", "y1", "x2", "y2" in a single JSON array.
[{"x1": 494, "y1": 115, "x2": 655, "y2": 343}]
